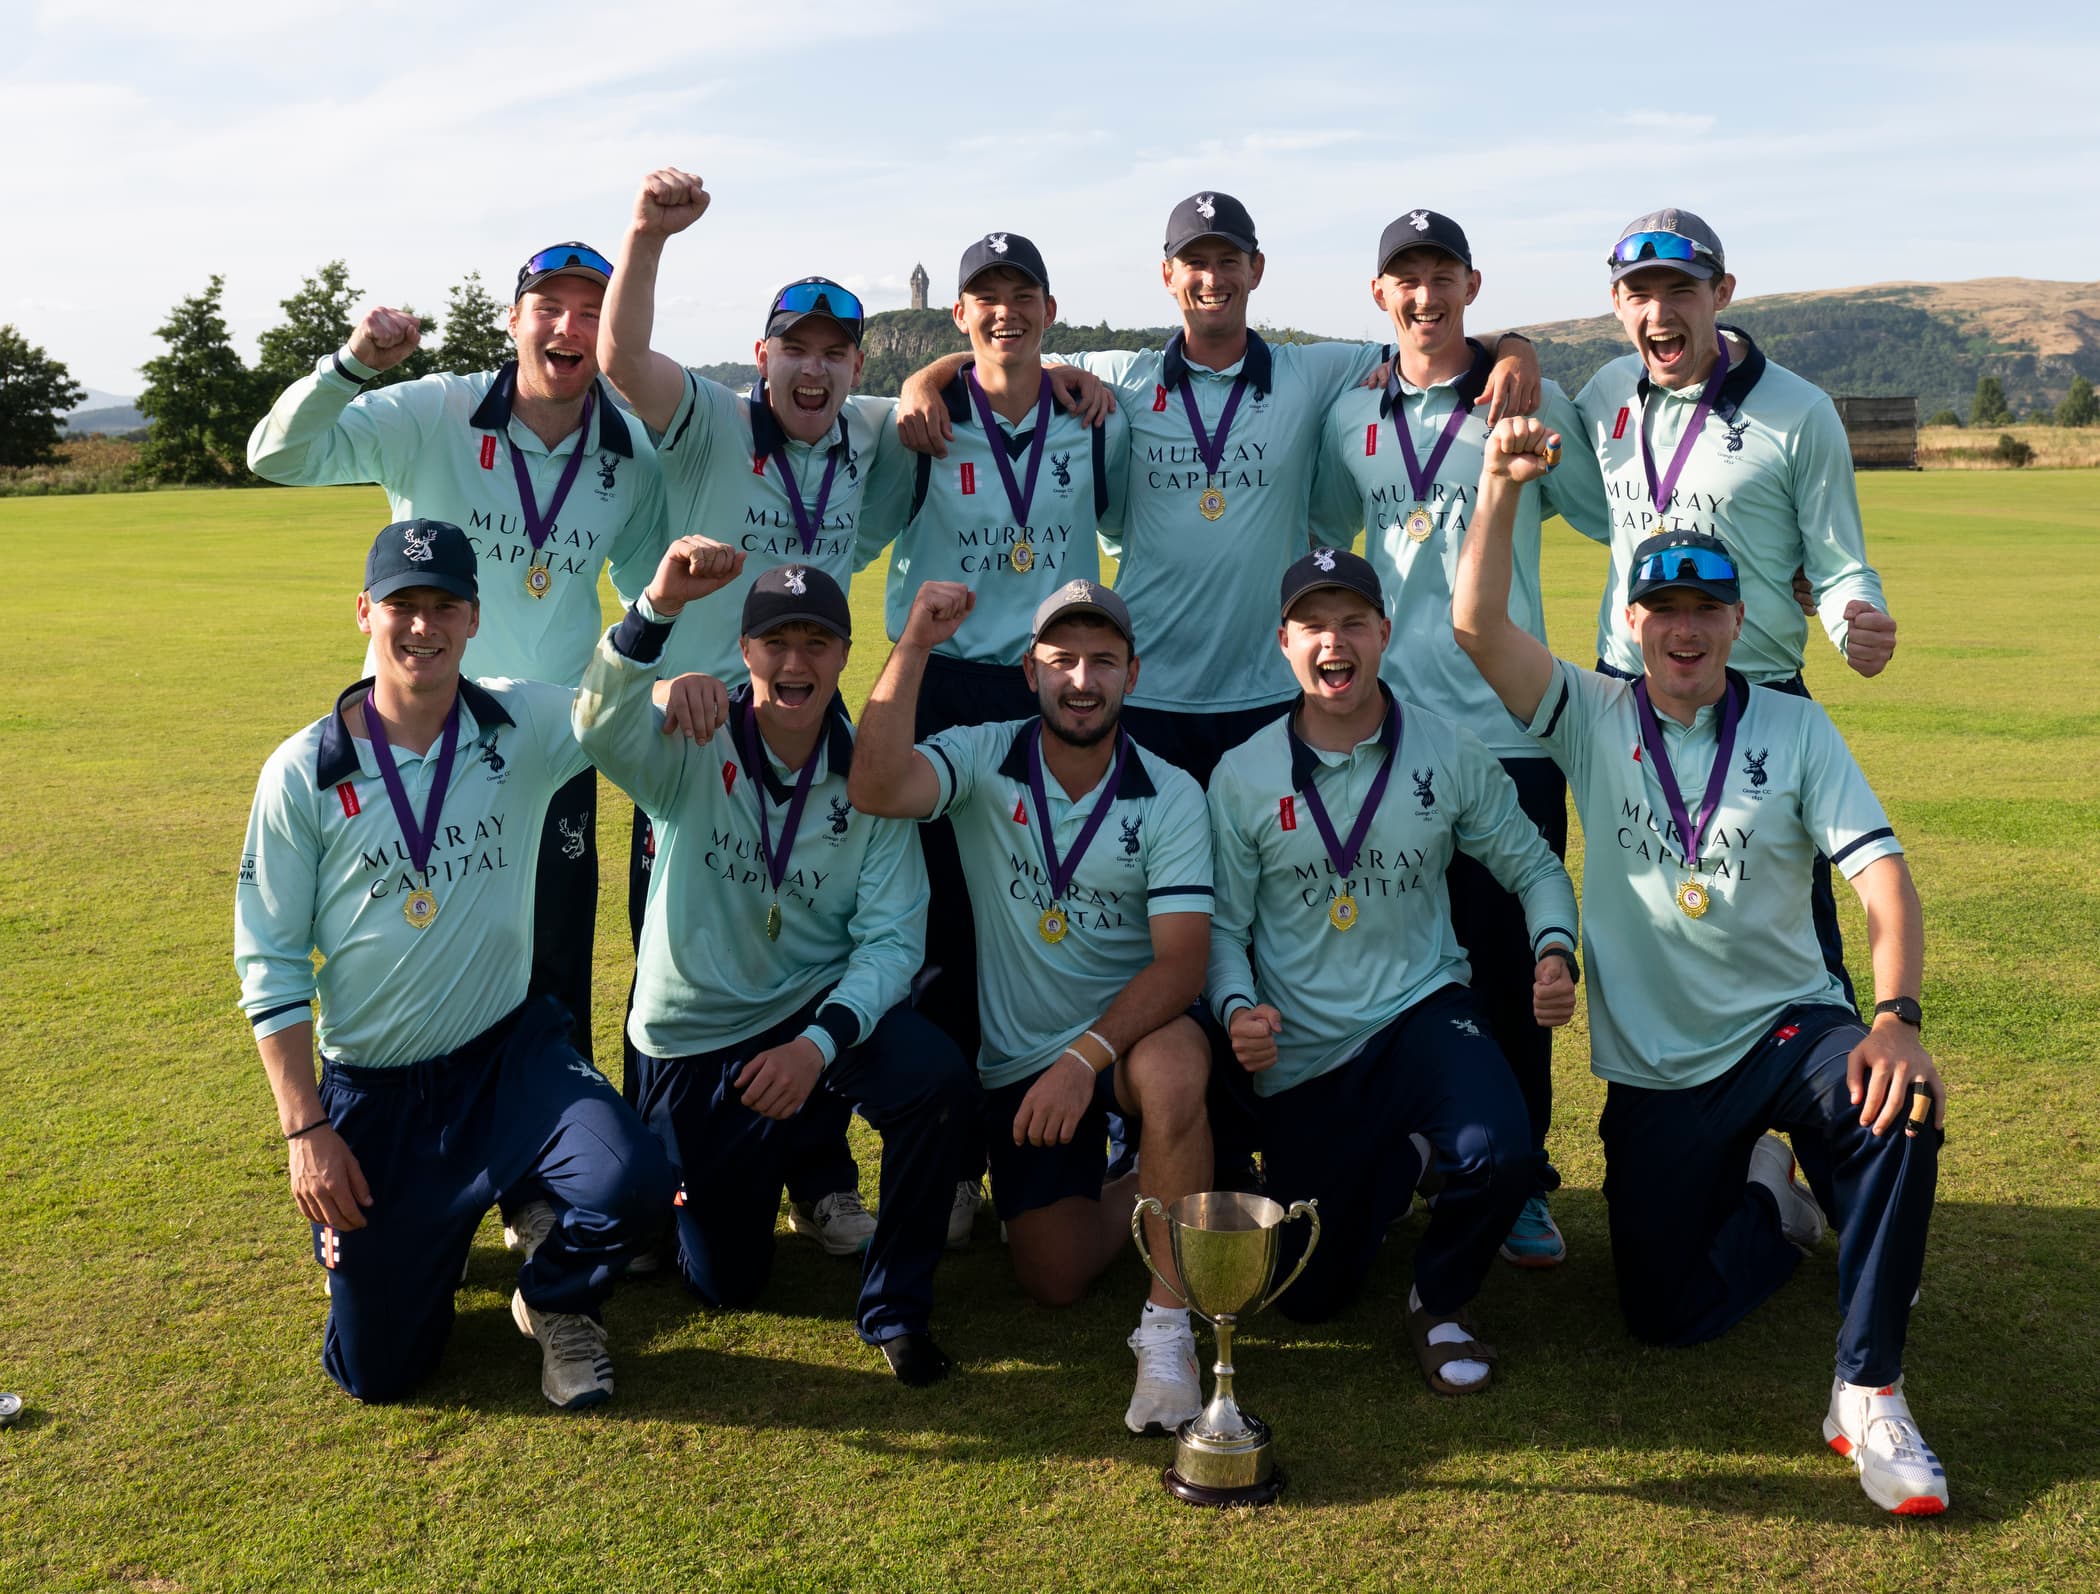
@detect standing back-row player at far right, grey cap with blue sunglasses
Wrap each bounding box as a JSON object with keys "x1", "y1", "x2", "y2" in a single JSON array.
[{"x1": 1575, "y1": 210, "x2": 1896, "y2": 1002}]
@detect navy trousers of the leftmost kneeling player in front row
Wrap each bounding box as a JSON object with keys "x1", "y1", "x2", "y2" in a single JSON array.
[{"x1": 313, "y1": 995, "x2": 672, "y2": 1401}]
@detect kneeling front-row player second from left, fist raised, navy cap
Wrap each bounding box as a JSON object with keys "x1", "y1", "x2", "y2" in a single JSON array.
[{"x1": 575, "y1": 538, "x2": 972, "y2": 1384}]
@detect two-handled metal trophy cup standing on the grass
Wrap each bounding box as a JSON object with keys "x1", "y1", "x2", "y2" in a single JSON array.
[{"x1": 1130, "y1": 1191, "x2": 1319, "y2": 1506}]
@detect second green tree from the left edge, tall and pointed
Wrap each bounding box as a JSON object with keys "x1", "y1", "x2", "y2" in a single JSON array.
[{"x1": 132, "y1": 275, "x2": 256, "y2": 485}]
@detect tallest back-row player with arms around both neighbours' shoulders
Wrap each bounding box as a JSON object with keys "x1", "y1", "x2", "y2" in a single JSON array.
[{"x1": 897, "y1": 191, "x2": 1537, "y2": 783}]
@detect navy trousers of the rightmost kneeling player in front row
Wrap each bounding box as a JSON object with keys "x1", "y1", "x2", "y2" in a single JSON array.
[{"x1": 1598, "y1": 1004, "x2": 1940, "y2": 1386}]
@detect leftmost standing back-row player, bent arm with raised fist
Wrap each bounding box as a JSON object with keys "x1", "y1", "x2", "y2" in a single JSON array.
[{"x1": 248, "y1": 244, "x2": 664, "y2": 1058}]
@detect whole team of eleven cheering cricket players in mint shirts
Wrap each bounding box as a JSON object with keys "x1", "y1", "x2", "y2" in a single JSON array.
[{"x1": 235, "y1": 168, "x2": 1949, "y2": 1514}]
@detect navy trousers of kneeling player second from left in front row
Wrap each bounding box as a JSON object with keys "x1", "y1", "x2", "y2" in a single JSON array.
[{"x1": 641, "y1": 998, "x2": 977, "y2": 1344}]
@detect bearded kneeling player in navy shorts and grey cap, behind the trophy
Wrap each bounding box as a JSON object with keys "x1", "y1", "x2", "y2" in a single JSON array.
[{"x1": 853, "y1": 580, "x2": 1212, "y2": 1432}]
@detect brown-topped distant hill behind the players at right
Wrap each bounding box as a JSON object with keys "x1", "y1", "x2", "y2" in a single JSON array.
[{"x1": 1525, "y1": 277, "x2": 2100, "y2": 420}]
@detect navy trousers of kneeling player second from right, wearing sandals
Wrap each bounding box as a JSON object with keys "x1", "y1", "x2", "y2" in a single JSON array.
[{"x1": 1212, "y1": 985, "x2": 1546, "y2": 1323}]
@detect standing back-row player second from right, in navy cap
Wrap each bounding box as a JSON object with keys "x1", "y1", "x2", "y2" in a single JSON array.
[{"x1": 1313, "y1": 208, "x2": 1611, "y2": 1268}]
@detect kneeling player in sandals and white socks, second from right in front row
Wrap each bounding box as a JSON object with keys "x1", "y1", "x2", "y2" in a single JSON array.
[{"x1": 1210, "y1": 548, "x2": 1575, "y2": 1394}]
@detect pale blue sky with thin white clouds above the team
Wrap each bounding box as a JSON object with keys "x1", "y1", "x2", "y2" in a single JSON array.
[{"x1": 0, "y1": 0, "x2": 2100, "y2": 395}]
